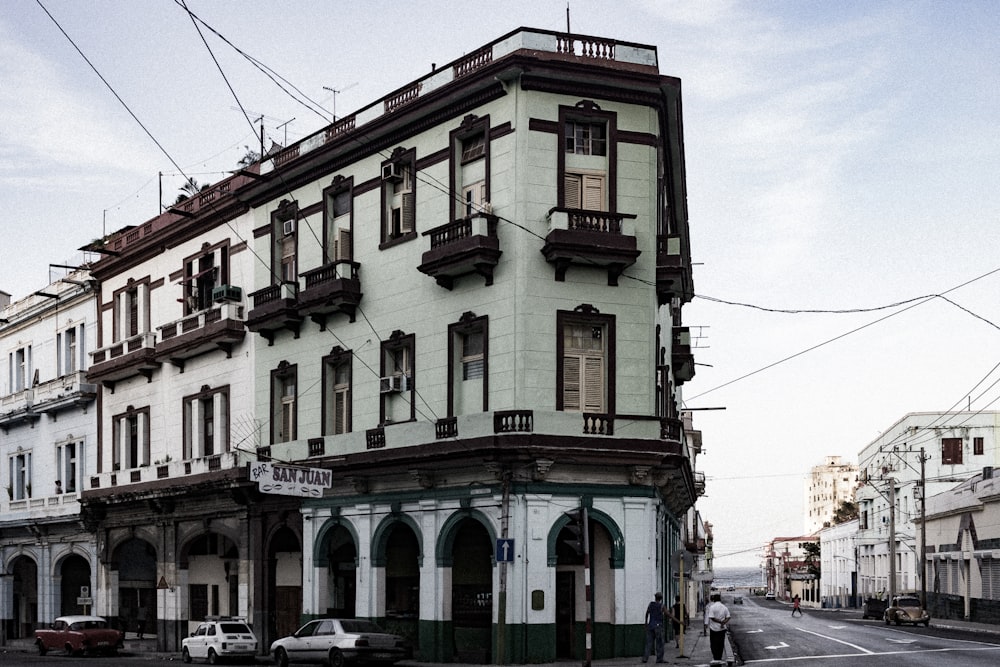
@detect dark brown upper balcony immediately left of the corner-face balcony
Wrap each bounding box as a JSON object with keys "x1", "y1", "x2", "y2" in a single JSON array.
[{"x1": 417, "y1": 213, "x2": 503, "y2": 290}]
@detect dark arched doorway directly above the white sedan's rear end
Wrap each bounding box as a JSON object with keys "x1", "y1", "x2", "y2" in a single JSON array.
[{"x1": 384, "y1": 521, "x2": 421, "y2": 648}]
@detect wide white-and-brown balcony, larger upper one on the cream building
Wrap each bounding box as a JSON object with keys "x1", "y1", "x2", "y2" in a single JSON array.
[{"x1": 156, "y1": 303, "x2": 246, "y2": 370}]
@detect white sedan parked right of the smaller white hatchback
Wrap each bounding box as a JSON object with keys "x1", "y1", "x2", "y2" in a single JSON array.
[{"x1": 271, "y1": 618, "x2": 406, "y2": 667}]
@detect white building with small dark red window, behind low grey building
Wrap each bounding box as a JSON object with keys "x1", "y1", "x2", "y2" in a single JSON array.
[{"x1": 857, "y1": 411, "x2": 1000, "y2": 597}]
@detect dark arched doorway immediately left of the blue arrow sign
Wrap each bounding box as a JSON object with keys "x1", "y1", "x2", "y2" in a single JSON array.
[{"x1": 451, "y1": 518, "x2": 493, "y2": 664}]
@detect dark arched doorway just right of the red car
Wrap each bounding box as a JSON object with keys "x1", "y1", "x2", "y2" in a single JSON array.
[{"x1": 114, "y1": 537, "x2": 156, "y2": 633}]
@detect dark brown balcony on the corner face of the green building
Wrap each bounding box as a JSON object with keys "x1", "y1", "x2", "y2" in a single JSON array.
[{"x1": 542, "y1": 208, "x2": 640, "y2": 286}]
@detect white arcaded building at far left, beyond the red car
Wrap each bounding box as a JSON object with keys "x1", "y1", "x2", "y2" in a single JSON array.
[{"x1": 0, "y1": 268, "x2": 97, "y2": 639}]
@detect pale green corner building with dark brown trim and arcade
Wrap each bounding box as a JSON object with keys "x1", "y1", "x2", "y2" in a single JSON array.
[{"x1": 236, "y1": 28, "x2": 697, "y2": 663}]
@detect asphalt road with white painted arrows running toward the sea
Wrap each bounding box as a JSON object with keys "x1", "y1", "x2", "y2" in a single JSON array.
[{"x1": 723, "y1": 596, "x2": 1000, "y2": 667}]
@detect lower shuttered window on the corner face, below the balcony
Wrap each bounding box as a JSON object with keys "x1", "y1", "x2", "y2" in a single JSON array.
[{"x1": 556, "y1": 306, "x2": 614, "y2": 414}]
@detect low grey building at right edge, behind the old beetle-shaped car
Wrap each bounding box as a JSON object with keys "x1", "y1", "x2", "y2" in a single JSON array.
[{"x1": 919, "y1": 468, "x2": 1000, "y2": 624}]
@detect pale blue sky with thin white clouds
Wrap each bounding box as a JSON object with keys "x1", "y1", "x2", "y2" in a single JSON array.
[{"x1": 0, "y1": 0, "x2": 1000, "y2": 567}]
